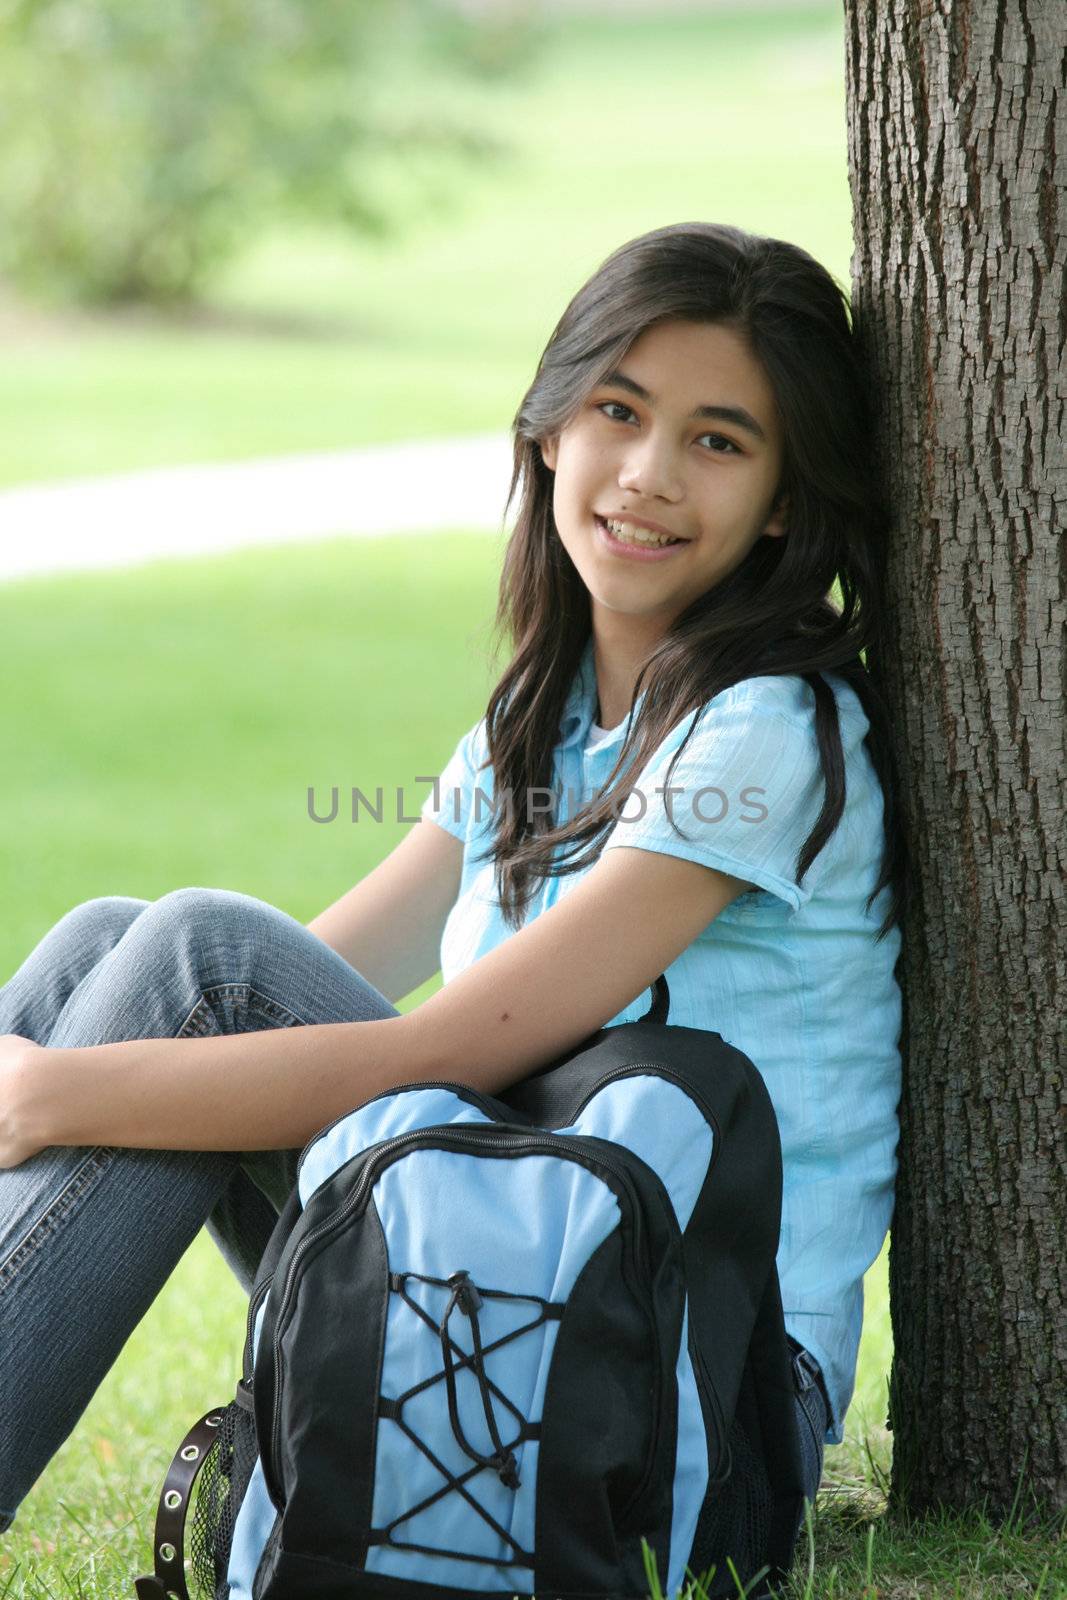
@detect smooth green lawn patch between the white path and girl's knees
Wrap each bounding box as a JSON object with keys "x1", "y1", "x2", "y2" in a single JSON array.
[{"x1": 0, "y1": 534, "x2": 501, "y2": 970}]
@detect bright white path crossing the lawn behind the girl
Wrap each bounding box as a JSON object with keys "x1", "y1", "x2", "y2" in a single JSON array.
[{"x1": 0, "y1": 434, "x2": 514, "y2": 581}]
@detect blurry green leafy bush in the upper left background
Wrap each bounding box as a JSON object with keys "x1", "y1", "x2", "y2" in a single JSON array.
[{"x1": 0, "y1": 0, "x2": 542, "y2": 304}]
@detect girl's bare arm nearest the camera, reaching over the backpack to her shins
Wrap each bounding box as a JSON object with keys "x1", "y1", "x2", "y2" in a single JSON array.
[{"x1": 8, "y1": 851, "x2": 750, "y2": 1162}]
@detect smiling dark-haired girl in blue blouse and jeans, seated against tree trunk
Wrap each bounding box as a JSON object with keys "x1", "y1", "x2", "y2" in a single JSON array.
[{"x1": 0, "y1": 224, "x2": 904, "y2": 1528}]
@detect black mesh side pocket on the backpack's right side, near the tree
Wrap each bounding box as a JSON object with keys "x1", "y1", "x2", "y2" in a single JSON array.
[{"x1": 689, "y1": 1382, "x2": 773, "y2": 1600}]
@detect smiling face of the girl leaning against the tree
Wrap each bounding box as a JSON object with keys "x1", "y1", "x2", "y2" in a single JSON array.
[{"x1": 541, "y1": 322, "x2": 785, "y2": 643}]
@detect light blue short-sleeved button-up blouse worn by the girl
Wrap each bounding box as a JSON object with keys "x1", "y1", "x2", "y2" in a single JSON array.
[{"x1": 421, "y1": 640, "x2": 901, "y2": 1445}]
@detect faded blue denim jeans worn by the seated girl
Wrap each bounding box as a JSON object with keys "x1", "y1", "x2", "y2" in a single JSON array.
[{"x1": 0, "y1": 888, "x2": 825, "y2": 1531}]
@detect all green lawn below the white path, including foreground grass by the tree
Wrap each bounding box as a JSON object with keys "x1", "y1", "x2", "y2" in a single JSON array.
[{"x1": 0, "y1": 534, "x2": 1067, "y2": 1600}]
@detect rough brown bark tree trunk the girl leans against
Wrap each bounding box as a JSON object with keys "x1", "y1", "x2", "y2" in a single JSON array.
[{"x1": 845, "y1": 0, "x2": 1067, "y2": 1522}]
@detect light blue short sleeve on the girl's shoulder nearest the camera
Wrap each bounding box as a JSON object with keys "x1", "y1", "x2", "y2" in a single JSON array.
[{"x1": 603, "y1": 678, "x2": 824, "y2": 912}]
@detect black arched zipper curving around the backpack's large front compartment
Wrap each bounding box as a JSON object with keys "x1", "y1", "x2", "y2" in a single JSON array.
[{"x1": 261, "y1": 1123, "x2": 659, "y2": 1510}]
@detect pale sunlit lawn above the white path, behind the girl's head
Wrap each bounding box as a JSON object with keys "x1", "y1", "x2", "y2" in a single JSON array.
[{"x1": 0, "y1": 0, "x2": 851, "y2": 483}]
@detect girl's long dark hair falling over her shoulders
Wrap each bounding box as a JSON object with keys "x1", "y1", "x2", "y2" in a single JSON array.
[{"x1": 480, "y1": 222, "x2": 907, "y2": 939}]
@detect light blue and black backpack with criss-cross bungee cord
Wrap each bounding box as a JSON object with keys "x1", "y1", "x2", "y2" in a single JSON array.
[{"x1": 136, "y1": 978, "x2": 803, "y2": 1600}]
